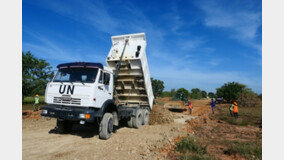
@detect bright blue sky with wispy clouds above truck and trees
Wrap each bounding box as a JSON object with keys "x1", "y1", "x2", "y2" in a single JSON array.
[{"x1": 22, "y1": 0, "x2": 262, "y2": 93}]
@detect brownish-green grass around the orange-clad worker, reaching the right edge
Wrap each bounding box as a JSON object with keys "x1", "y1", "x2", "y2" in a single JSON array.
[{"x1": 216, "y1": 104, "x2": 262, "y2": 126}]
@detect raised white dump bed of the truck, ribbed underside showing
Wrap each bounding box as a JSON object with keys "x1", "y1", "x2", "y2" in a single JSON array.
[{"x1": 106, "y1": 33, "x2": 154, "y2": 109}]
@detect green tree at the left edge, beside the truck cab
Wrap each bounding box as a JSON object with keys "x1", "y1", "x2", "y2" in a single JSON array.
[{"x1": 22, "y1": 51, "x2": 53, "y2": 98}]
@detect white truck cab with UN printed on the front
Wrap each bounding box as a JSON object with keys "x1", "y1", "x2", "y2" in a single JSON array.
[{"x1": 45, "y1": 62, "x2": 113, "y2": 108}]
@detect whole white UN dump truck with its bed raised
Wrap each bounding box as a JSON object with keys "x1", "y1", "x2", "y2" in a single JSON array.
[{"x1": 41, "y1": 33, "x2": 154, "y2": 139}]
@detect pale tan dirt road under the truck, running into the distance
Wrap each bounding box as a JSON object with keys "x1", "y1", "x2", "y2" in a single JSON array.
[{"x1": 22, "y1": 101, "x2": 209, "y2": 160}]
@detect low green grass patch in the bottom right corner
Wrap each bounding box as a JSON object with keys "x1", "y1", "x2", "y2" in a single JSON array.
[{"x1": 224, "y1": 140, "x2": 262, "y2": 159}]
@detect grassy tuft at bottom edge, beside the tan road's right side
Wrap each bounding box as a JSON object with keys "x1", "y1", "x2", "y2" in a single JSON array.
[{"x1": 175, "y1": 137, "x2": 215, "y2": 160}]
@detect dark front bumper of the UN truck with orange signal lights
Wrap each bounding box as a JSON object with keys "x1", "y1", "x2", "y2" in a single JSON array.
[{"x1": 41, "y1": 104, "x2": 95, "y2": 122}]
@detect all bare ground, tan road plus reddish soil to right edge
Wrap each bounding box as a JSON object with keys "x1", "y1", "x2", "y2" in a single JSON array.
[{"x1": 22, "y1": 98, "x2": 262, "y2": 160}]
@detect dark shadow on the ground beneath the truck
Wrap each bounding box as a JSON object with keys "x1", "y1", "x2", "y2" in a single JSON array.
[{"x1": 48, "y1": 123, "x2": 127, "y2": 138}]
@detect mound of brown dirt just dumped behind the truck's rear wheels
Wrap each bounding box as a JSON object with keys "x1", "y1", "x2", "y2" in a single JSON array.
[{"x1": 149, "y1": 105, "x2": 174, "y2": 125}]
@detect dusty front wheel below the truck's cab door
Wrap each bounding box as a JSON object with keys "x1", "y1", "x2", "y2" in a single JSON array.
[{"x1": 99, "y1": 113, "x2": 113, "y2": 139}]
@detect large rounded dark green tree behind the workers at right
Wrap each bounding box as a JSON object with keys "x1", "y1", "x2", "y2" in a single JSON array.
[{"x1": 216, "y1": 82, "x2": 247, "y2": 101}]
